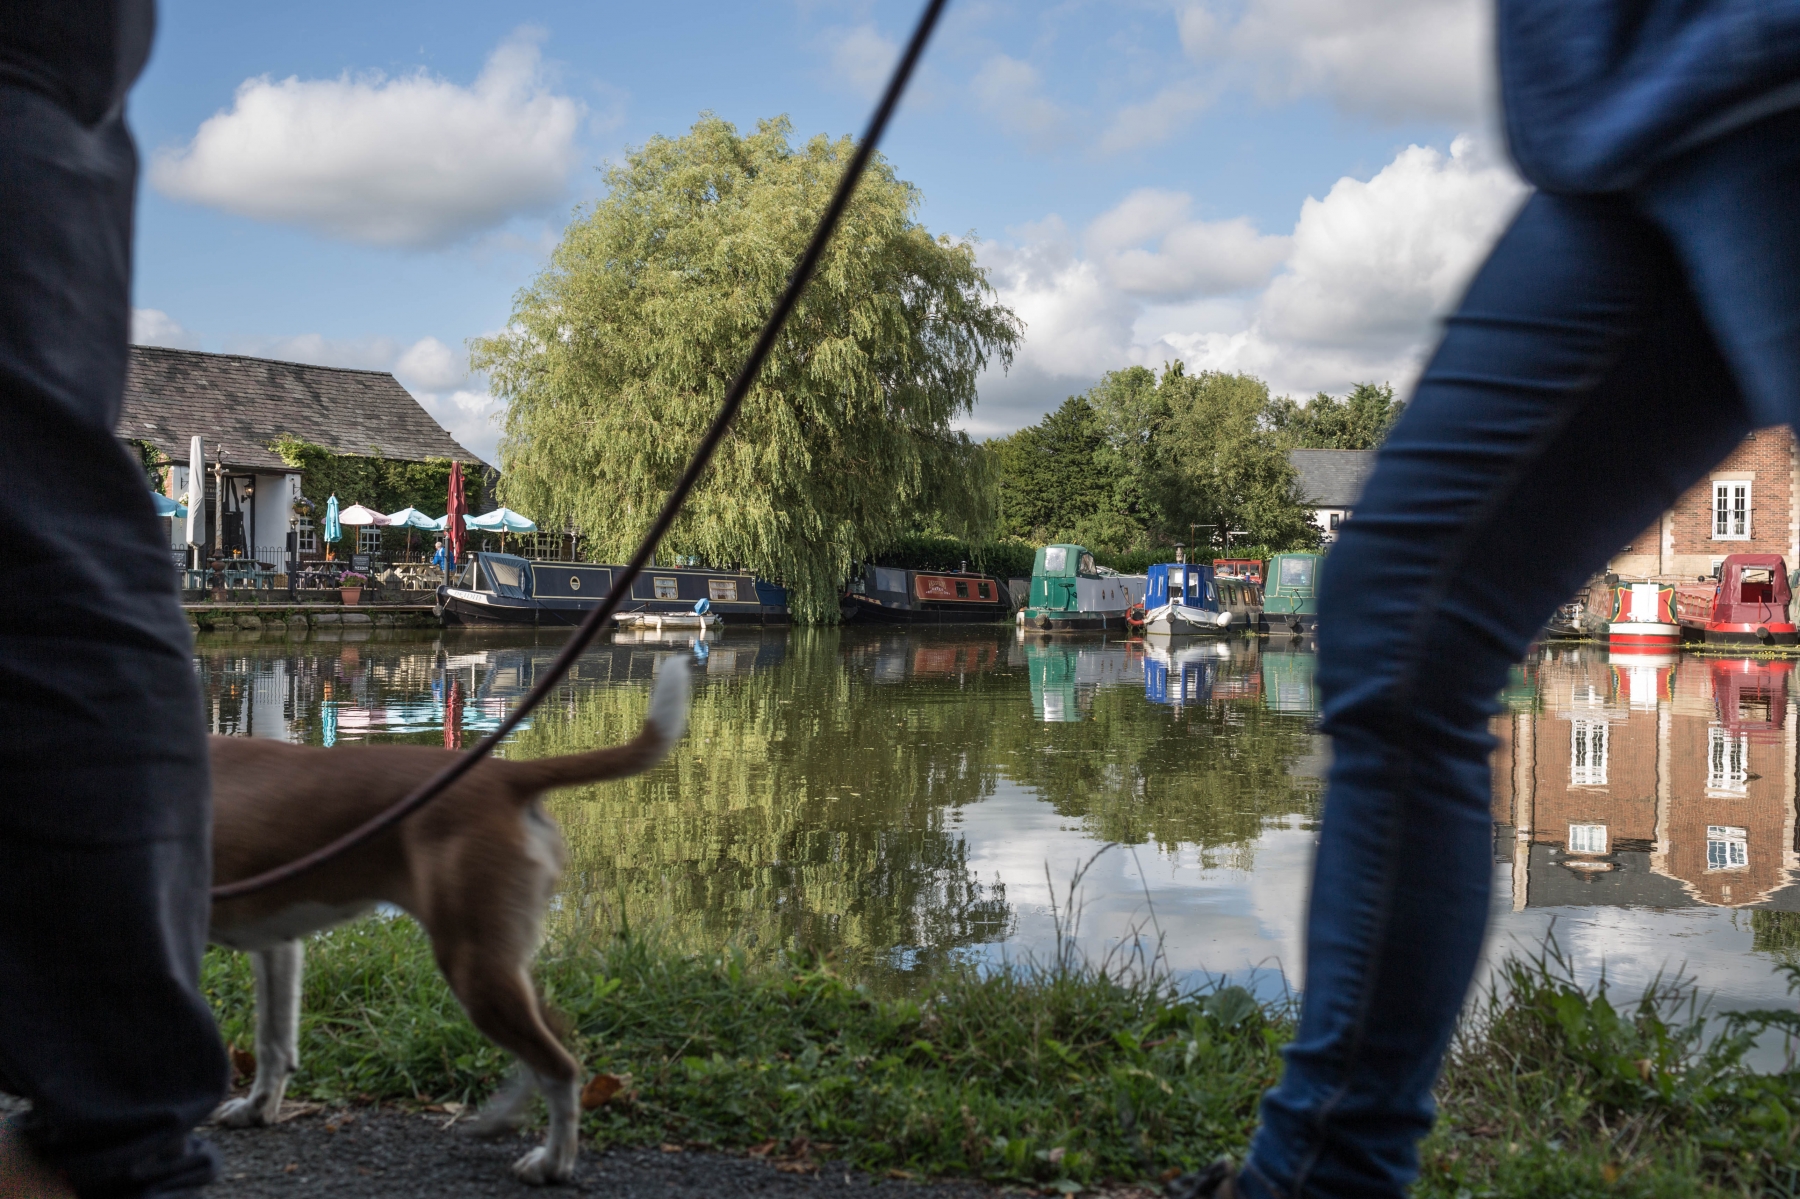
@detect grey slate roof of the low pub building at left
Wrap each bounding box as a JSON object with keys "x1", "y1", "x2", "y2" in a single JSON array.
[{"x1": 115, "y1": 346, "x2": 482, "y2": 470}]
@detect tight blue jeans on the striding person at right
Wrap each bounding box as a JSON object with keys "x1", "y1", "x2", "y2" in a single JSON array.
[{"x1": 1240, "y1": 107, "x2": 1800, "y2": 1199}]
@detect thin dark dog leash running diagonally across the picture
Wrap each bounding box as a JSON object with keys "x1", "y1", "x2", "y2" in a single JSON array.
[{"x1": 212, "y1": 0, "x2": 949, "y2": 904}]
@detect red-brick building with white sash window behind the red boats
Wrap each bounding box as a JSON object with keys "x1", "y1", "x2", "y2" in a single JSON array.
[{"x1": 1607, "y1": 425, "x2": 1800, "y2": 580}]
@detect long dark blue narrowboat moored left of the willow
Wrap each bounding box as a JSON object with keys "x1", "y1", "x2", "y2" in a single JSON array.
[{"x1": 436, "y1": 551, "x2": 788, "y2": 627}]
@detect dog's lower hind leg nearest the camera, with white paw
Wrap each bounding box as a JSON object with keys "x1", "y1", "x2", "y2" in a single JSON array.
[{"x1": 450, "y1": 949, "x2": 581, "y2": 1185}]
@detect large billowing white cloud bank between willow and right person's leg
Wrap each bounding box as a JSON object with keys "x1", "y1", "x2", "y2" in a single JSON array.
[{"x1": 968, "y1": 137, "x2": 1525, "y2": 434}]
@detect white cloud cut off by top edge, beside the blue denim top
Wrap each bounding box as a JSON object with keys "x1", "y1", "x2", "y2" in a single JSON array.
[{"x1": 1179, "y1": 0, "x2": 1494, "y2": 124}]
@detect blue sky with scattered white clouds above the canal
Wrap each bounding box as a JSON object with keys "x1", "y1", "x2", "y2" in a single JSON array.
[{"x1": 130, "y1": 0, "x2": 1525, "y2": 464}]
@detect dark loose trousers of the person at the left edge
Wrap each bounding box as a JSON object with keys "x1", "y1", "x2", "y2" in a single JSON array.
[{"x1": 0, "y1": 85, "x2": 227, "y2": 1197}]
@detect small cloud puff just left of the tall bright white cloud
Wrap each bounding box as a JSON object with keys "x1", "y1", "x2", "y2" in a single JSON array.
[{"x1": 1085, "y1": 187, "x2": 1289, "y2": 299}]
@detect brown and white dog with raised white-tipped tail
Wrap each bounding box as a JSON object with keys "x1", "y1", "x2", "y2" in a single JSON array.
[{"x1": 211, "y1": 659, "x2": 688, "y2": 1185}]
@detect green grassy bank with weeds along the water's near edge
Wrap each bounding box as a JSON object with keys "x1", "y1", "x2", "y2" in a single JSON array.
[{"x1": 205, "y1": 920, "x2": 1800, "y2": 1197}]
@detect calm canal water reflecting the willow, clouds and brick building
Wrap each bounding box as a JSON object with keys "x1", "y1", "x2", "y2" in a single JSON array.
[{"x1": 194, "y1": 627, "x2": 1800, "y2": 1008}]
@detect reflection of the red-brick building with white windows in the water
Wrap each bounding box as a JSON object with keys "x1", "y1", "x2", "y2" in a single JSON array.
[{"x1": 1494, "y1": 648, "x2": 1800, "y2": 911}]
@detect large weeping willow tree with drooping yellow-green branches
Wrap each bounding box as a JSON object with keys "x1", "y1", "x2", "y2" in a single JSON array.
[{"x1": 472, "y1": 115, "x2": 1021, "y2": 621}]
